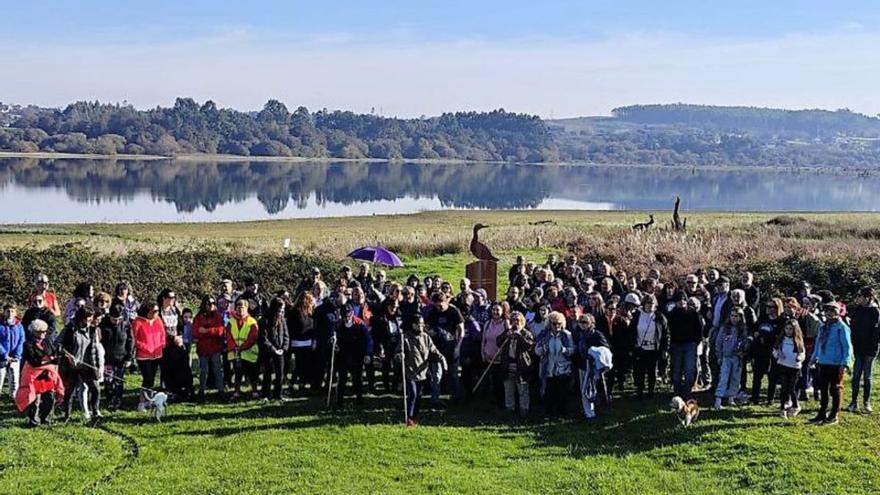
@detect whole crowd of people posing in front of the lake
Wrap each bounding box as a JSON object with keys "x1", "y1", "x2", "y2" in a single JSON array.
[{"x1": 0, "y1": 254, "x2": 868, "y2": 426}]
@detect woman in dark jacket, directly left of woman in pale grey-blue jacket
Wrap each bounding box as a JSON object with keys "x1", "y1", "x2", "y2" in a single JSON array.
[{"x1": 495, "y1": 311, "x2": 535, "y2": 416}]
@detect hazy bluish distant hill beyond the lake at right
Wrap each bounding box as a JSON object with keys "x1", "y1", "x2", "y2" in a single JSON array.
[{"x1": 547, "y1": 104, "x2": 880, "y2": 169}]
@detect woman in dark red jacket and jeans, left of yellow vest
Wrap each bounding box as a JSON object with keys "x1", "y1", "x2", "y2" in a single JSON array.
[{"x1": 193, "y1": 296, "x2": 226, "y2": 402}]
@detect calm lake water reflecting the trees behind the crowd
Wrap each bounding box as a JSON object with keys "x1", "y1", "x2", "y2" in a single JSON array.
[{"x1": 0, "y1": 158, "x2": 880, "y2": 223}]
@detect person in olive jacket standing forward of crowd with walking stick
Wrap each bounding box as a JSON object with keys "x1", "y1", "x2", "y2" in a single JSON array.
[{"x1": 395, "y1": 315, "x2": 446, "y2": 426}]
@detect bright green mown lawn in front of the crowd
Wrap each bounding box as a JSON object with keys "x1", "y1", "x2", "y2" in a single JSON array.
[{"x1": 0, "y1": 382, "x2": 880, "y2": 494}]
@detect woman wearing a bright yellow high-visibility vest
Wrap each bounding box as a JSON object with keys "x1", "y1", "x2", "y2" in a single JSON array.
[{"x1": 226, "y1": 299, "x2": 260, "y2": 399}]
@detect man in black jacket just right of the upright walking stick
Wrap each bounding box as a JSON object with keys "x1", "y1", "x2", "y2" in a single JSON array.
[{"x1": 332, "y1": 304, "x2": 373, "y2": 407}]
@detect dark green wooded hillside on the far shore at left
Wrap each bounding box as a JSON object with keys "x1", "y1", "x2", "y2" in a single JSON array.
[{"x1": 0, "y1": 98, "x2": 559, "y2": 162}]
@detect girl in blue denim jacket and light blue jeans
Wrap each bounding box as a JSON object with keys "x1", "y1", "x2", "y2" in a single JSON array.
[{"x1": 714, "y1": 307, "x2": 748, "y2": 410}]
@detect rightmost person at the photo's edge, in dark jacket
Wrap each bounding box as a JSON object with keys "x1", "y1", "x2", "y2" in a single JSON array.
[{"x1": 846, "y1": 287, "x2": 880, "y2": 413}]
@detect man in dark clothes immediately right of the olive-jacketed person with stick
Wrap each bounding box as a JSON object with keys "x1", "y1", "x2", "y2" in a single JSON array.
[{"x1": 425, "y1": 293, "x2": 464, "y2": 408}]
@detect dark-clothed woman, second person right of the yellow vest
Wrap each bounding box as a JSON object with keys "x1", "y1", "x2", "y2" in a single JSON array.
[{"x1": 287, "y1": 292, "x2": 321, "y2": 395}]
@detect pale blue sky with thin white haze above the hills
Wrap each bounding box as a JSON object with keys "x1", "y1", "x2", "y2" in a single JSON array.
[{"x1": 0, "y1": 0, "x2": 880, "y2": 118}]
